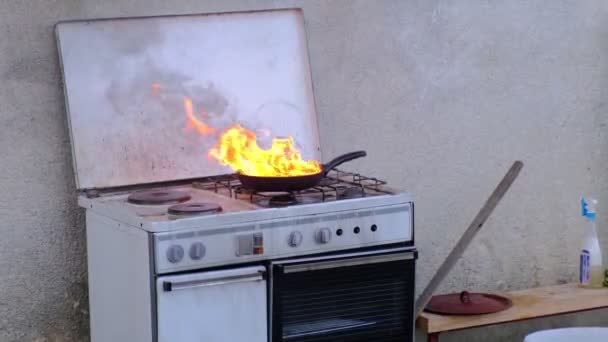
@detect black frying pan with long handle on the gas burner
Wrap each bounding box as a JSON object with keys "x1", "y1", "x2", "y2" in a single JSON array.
[{"x1": 238, "y1": 151, "x2": 367, "y2": 192}]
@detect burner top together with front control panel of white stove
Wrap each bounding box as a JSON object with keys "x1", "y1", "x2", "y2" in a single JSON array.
[{"x1": 79, "y1": 171, "x2": 413, "y2": 274}]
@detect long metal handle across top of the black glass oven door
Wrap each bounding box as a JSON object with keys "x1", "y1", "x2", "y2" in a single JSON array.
[{"x1": 277, "y1": 252, "x2": 416, "y2": 273}]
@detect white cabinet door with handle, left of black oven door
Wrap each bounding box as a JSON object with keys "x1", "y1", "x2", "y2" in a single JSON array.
[{"x1": 156, "y1": 267, "x2": 268, "y2": 342}]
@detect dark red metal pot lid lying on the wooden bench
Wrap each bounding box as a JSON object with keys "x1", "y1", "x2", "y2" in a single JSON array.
[{"x1": 425, "y1": 291, "x2": 513, "y2": 315}]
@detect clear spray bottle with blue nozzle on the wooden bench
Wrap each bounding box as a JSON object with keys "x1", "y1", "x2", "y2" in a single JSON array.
[{"x1": 580, "y1": 198, "x2": 604, "y2": 288}]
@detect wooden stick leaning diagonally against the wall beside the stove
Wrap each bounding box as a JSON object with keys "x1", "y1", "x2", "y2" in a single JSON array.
[{"x1": 414, "y1": 161, "x2": 524, "y2": 317}]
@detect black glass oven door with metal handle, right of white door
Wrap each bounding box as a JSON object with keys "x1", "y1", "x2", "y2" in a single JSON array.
[{"x1": 272, "y1": 249, "x2": 416, "y2": 342}]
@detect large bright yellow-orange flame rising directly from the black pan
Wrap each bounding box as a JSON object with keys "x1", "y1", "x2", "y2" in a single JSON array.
[{"x1": 209, "y1": 124, "x2": 321, "y2": 177}]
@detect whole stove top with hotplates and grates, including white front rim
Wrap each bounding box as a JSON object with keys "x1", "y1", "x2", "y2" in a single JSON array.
[{"x1": 79, "y1": 170, "x2": 409, "y2": 232}]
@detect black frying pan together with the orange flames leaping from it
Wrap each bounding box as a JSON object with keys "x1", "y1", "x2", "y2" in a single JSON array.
[{"x1": 152, "y1": 83, "x2": 366, "y2": 192}]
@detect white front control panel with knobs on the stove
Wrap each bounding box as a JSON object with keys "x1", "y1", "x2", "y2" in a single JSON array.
[{"x1": 154, "y1": 203, "x2": 413, "y2": 274}]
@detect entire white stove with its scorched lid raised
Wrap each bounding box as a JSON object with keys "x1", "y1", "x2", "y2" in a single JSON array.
[{"x1": 57, "y1": 9, "x2": 416, "y2": 342}]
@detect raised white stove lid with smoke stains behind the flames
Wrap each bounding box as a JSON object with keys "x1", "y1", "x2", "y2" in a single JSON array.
[{"x1": 56, "y1": 9, "x2": 320, "y2": 189}]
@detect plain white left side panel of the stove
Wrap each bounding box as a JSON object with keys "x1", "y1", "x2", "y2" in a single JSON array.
[{"x1": 86, "y1": 210, "x2": 154, "y2": 342}]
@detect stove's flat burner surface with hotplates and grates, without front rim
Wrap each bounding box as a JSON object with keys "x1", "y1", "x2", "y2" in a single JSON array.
[{"x1": 84, "y1": 170, "x2": 393, "y2": 215}]
